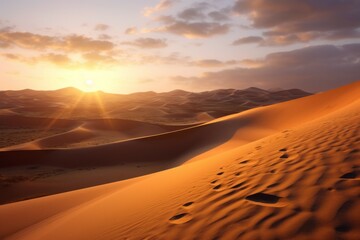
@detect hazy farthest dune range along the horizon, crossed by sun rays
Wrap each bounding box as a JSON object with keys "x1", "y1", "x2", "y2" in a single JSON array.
[{"x1": 0, "y1": 88, "x2": 310, "y2": 125}]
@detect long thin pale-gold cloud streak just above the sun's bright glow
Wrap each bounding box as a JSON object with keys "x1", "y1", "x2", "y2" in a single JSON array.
[{"x1": 0, "y1": 45, "x2": 242, "y2": 69}]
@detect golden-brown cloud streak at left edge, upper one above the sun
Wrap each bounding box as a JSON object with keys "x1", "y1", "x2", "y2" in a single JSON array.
[{"x1": 0, "y1": 31, "x2": 115, "y2": 52}]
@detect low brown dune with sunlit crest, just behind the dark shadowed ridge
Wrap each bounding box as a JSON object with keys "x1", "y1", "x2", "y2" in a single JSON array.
[{"x1": 0, "y1": 116, "x2": 187, "y2": 151}]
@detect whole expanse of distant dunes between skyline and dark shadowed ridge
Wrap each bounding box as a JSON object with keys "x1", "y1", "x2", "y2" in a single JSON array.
[{"x1": 0, "y1": 88, "x2": 309, "y2": 149}]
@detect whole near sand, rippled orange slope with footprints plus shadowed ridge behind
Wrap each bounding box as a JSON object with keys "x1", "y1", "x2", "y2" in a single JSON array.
[{"x1": 0, "y1": 81, "x2": 360, "y2": 239}]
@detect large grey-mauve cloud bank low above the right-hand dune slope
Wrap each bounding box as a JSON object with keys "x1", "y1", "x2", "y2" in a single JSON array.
[{"x1": 172, "y1": 44, "x2": 360, "y2": 91}]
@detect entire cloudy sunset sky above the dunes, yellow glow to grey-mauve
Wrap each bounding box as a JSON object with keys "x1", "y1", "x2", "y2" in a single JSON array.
[{"x1": 0, "y1": 0, "x2": 360, "y2": 93}]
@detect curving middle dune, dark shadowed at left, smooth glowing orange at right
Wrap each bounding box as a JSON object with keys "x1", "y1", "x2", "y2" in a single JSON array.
[{"x1": 0, "y1": 80, "x2": 358, "y2": 167}]
